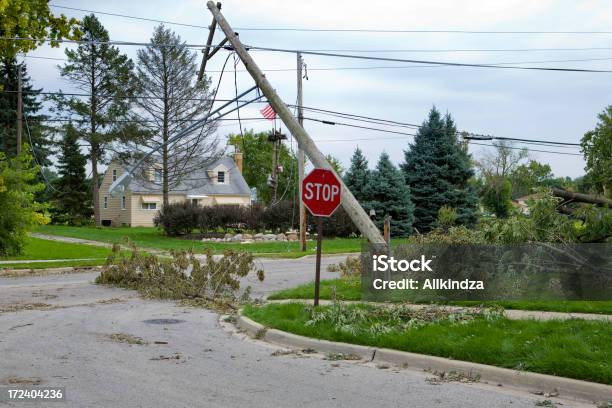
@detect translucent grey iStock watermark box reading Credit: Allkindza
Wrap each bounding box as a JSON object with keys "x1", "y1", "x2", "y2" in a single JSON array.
[{"x1": 361, "y1": 243, "x2": 612, "y2": 302}]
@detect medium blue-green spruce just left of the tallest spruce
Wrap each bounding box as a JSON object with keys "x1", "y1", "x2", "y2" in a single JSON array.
[{"x1": 363, "y1": 152, "x2": 414, "y2": 237}]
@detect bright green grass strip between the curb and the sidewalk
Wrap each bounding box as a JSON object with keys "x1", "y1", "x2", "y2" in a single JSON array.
[{"x1": 244, "y1": 303, "x2": 612, "y2": 384}]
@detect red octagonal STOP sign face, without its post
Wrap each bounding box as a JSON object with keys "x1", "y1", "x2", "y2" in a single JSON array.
[{"x1": 302, "y1": 169, "x2": 342, "y2": 217}]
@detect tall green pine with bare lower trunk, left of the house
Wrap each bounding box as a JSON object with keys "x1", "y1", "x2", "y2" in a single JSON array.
[{"x1": 55, "y1": 14, "x2": 134, "y2": 224}]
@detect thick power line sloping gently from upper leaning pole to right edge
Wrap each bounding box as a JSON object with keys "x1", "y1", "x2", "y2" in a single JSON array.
[{"x1": 249, "y1": 46, "x2": 612, "y2": 73}]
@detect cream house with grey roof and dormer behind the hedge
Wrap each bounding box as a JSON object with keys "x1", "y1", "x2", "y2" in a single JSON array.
[{"x1": 99, "y1": 152, "x2": 251, "y2": 227}]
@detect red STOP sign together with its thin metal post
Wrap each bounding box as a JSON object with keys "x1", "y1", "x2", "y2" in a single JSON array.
[{"x1": 302, "y1": 169, "x2": 342, "y2": 306}]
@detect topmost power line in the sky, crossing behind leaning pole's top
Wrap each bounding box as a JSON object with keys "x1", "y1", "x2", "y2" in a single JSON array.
[{"x1": 49, "y1": 4, "x2": 612, "y2": 35}]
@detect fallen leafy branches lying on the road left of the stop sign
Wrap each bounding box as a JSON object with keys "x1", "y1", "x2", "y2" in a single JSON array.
[{"x1": 96, "y1": 245, "x2": 264, "y2": 310}]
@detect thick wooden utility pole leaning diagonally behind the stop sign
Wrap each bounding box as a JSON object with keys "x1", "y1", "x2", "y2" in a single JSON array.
[{"x1": 206, "y1": 1, "x2": 386, "y2": 247}]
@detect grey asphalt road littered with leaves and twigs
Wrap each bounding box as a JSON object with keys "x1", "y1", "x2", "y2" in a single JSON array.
[{"x1": 0, "y1": 258, "x2": 580, "y2": 408}]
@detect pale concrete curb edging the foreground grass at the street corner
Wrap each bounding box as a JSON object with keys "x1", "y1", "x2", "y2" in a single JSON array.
[{"x1": 236, "y1": 310, "x2": 612, "y2": 403}]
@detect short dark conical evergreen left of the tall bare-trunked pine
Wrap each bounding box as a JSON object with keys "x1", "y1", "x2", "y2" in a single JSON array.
[{"x1": 52, "y1": 124, "x2": 92, "y2": 225}]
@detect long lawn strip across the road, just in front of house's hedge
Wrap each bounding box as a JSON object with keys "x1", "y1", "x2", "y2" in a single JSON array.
[{"x1": 36, "y1": 225, "x2": 376, "y2": 258}]
